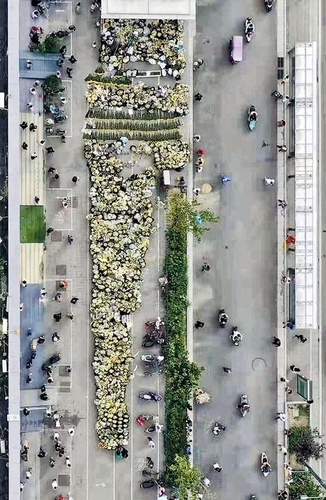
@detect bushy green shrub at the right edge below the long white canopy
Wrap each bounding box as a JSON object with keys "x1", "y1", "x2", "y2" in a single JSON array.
[{"x1": 289, "y1": 426, "x2": 326, "y2": 463}]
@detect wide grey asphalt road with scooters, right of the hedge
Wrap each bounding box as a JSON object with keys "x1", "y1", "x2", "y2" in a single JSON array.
[{"x1": 194, "y1": 0, "x2": 277, "y2": 500}]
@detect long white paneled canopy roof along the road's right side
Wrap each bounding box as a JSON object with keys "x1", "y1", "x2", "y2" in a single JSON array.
[{"x1": 294, "y1": 42, "x2": 318, "y2": 328}]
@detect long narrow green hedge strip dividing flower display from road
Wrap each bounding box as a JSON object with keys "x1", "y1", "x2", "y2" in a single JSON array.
[{"x1": 164, "y1": 194, "x2": 209, "y2": 484}]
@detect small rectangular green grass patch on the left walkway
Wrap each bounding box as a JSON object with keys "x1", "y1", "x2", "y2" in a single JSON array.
[{"x1": 20, "y1": 205, "x2": 45, "y2": 243}]
